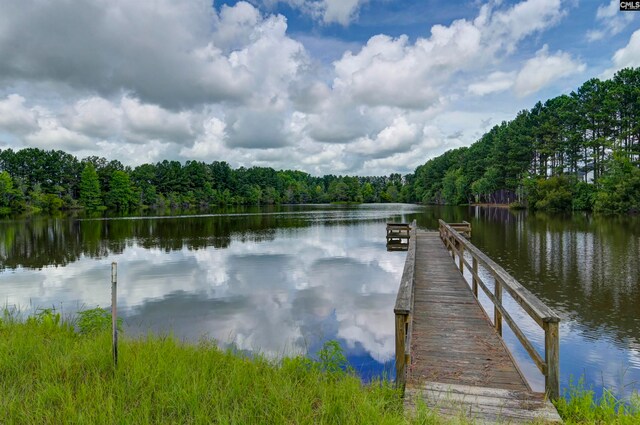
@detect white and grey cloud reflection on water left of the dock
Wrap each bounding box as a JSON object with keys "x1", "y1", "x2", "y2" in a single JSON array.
[{"x1": 3, "y1": 219, "x2": 404, "y2": 372}]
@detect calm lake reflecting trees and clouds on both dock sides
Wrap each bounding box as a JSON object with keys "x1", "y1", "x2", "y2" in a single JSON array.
[{"x1": 0, "y1": 204, "x2": 640, "y2": 396}]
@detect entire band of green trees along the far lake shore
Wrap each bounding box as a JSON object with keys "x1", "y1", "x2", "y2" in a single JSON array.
[{"x1": 0, "y1": 68, "x2": 640, "y2": 219}]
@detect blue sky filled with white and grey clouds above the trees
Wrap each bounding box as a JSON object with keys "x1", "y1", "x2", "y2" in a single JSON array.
[{"x1": 0, "y1": 0, "x2": 640, "y2": 175}]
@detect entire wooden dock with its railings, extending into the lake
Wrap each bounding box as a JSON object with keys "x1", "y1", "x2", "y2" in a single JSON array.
[{"x1": 395, "y1": 222, "x2": 561, "y2": 423}]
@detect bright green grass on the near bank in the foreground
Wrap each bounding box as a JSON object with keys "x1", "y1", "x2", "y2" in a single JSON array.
[{"x1": 0, "y1": 308, "x2": 640, "y2": 424}]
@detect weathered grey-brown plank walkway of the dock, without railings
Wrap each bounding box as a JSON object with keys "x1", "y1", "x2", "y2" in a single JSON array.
[{"x1": 397, "y1": 231, "x2": 561, "y2": 423}]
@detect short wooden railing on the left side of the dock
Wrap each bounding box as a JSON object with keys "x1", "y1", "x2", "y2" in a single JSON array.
[{"x1": 393, "y1": 220, "x2": 417, "y2": 389}]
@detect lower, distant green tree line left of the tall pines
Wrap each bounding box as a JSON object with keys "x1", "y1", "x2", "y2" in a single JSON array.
[{"x1": 0, "y1": 148, "x2": 409, "y2": 215}]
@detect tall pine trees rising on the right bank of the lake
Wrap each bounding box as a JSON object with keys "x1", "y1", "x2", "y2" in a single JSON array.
[{"x1": 410, "y1": 68, "x2": 640, "y2": 213}]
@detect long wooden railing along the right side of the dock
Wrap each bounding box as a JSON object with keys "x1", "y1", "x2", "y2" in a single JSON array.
[{"x1": 436, "y1": 220, "x2": 560, "y2": 400}]
